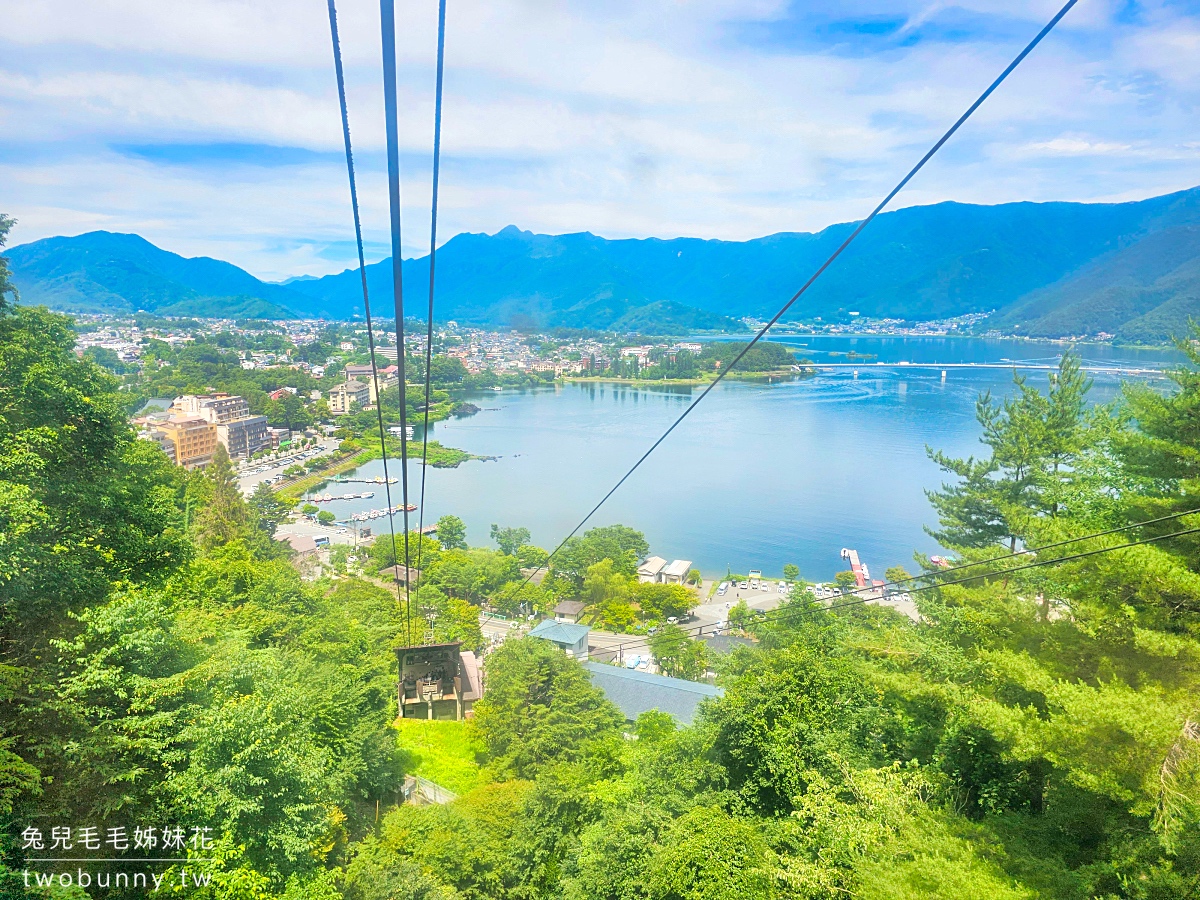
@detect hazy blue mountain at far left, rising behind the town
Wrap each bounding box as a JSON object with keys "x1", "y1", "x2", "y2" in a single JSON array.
[{"x1": 8, "y1": 232, "x2": 308, "y2": 318}]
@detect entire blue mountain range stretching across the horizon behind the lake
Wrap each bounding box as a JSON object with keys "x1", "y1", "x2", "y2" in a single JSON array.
[{"x1": 10, "y1": 188, "x2": 1200, "y2": 341}]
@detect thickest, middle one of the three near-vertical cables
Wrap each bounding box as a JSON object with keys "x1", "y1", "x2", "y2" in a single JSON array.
[{"x1": 379, "y1": 0, "x2": 415, "y2": 643}]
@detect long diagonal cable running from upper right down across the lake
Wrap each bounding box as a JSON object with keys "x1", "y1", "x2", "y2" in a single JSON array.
[{"x1": 487, "y1": 0, "x2": 1079, "y2": 614}]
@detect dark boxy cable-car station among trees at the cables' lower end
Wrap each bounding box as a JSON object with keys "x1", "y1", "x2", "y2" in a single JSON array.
[{"x1": 396, "y1": 641, "x2": 484, "y2": 720}]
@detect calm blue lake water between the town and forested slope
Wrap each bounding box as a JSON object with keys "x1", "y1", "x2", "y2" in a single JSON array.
[{"x1": 304, "y1": 336, "x2": 1181, "y2": 580}]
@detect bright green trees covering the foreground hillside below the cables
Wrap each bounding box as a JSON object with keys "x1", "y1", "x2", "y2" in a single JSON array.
[{"x1": 0, "y1": 214, "x2": 1200, "y2": 900}]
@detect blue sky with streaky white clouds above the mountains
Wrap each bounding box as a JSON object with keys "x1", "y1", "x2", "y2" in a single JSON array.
[{"x1": 0, "y1": 0, "x2": 1200, "y2": 278}]
